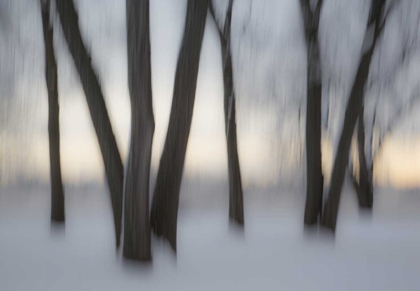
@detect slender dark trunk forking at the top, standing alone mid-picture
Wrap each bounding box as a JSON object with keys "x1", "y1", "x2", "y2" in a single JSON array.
[{"x1": 210, "y1": 0, "x2": 244, "y2": 225}]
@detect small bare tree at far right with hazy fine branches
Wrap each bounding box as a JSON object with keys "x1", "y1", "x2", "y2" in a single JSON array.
[{"x1": 350, "y1": 1, "x2": 420, "y2": 209}]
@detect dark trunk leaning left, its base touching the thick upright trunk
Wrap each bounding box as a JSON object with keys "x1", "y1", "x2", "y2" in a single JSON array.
[{"x1": 56, "y1": 0, "x2": 124, "y2": 247}]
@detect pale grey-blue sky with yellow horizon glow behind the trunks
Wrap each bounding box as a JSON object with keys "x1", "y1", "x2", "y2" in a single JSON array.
[{"x1": 0, "y1": 0, "x2": 420, "y2": 188}]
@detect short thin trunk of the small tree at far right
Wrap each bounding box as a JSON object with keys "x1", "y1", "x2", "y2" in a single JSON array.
[{"x1": 357, "y1": 106, "x2": 373, "y2": 208}]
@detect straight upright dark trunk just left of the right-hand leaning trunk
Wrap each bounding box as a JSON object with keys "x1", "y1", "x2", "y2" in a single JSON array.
[{"x1": 300, "y1": 0, "x2": 324, "y2": 225}]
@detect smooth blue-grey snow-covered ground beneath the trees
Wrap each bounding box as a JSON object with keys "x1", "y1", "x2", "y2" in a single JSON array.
[{"x1": 0, "y1": 184, "x2": 420, "y2": 291}]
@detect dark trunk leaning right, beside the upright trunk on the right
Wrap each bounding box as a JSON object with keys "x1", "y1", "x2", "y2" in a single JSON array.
[{"x1": 321, "y1": 0, "x2": 398, "y2": 231}]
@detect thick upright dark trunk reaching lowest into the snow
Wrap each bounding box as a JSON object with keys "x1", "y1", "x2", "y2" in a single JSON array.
[{"x1": 123, "y1": 0, "x2": 155, "y2": 261}]
